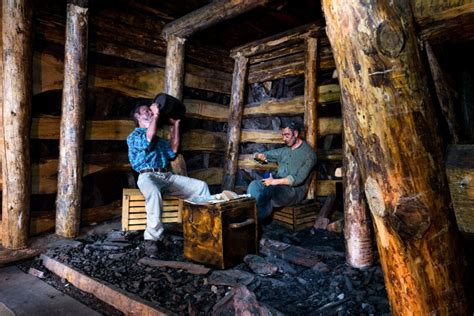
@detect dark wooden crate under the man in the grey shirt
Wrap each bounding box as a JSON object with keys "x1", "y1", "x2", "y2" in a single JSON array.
[{"x1": 272, "y1": 200, "x2": 319, "y2": 231}]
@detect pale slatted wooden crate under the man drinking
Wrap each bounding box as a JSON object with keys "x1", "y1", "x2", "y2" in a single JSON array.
[{"x1": 122, "y1": 189, "x2": 183, "y2": 230}]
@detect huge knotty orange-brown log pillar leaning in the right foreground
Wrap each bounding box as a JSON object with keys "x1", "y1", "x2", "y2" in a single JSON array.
[{"x1": 322, "y1": 0, "x2": 467, "y2": 315}]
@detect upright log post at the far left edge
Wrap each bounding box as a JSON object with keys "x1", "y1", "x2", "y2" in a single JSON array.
[{"x1": 2, "y1": 0, "x2": 33, "y2": 249}]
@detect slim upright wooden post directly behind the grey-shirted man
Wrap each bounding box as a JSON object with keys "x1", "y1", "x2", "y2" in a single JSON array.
[{"x1": 304, "y1": 37, "x2": 318, "y2": 199}]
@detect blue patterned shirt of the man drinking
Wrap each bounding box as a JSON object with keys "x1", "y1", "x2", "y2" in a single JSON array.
[{"x1": 127, "y1": 127, "x2": 176, "y2": 172}]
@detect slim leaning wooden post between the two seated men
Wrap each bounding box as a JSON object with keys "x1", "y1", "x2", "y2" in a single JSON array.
[{"x1": 222, "y1": 53, "x2": 248, "y2": 190}]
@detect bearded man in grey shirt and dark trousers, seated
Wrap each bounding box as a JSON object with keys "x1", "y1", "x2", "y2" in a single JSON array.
[{"x1": 247, "y1": 122, "x2": 316, "y2": 220}]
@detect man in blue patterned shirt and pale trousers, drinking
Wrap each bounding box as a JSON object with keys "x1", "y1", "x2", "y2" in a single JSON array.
[{"x1": 127, "y1": 102, "x2": 210, "y2": 256}]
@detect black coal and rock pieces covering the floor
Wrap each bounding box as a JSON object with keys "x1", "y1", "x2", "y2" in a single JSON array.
[{"x1": 38, "y1": 223, "x2": 390, "y2": 315}]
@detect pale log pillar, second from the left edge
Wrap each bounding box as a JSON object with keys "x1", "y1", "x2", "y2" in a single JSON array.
[{"x1": 56, "y1": 0, "x2": 89, "y2": 237}]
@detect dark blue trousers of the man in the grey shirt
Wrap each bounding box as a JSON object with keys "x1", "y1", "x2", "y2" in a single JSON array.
[{"x1": 247, "y1": 180, "x2": 307, "y2": 221}]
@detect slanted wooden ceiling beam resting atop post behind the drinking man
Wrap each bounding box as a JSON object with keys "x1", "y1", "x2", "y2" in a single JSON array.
[{"x1": 163, "y1": 0, "x2": 269, "y2": 39}]
